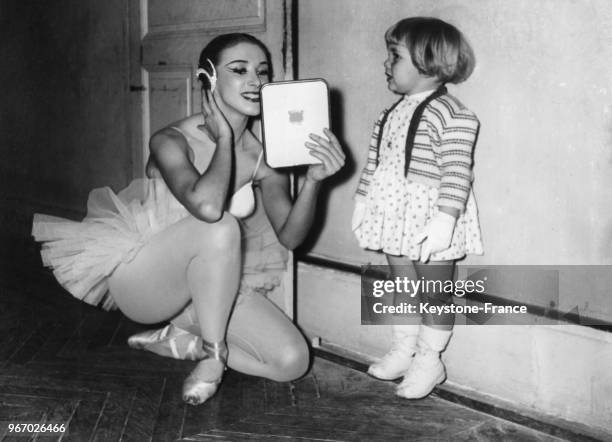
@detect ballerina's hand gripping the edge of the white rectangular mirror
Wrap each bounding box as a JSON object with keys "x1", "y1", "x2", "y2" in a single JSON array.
[{"x1": 304, "y1": 129, "x2": 346, "y2": 181}]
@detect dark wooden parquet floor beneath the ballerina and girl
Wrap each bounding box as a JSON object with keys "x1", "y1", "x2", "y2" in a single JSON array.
[{"x1": 0, "y1": 273, "x2": 584, "y2": 441}]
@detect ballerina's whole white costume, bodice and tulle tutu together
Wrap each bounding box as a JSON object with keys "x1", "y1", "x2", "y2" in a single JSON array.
[{"x1": 32, "y1": 128, "x2": 287, "y2": 310}]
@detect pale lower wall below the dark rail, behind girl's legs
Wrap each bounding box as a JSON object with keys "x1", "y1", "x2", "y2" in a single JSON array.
[{"x1": 296, "y1": 263, "x2": 612, "y2": 440}]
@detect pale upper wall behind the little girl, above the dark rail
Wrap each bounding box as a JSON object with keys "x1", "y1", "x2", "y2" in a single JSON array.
[{"x1": 298, "y1": 0, "x2": 612, "y2": 320}]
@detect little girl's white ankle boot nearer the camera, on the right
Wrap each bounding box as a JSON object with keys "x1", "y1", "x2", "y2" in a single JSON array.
[{"x1": 395, "y1": 326, "x2": 452, "y2": 399}]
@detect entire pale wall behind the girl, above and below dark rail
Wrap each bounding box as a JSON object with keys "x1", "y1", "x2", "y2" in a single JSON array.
[{"x1": 298, "y1": 0, "x2": 612, "y2": 434}]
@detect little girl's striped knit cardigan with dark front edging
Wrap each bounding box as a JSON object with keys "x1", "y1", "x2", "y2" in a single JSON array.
[{"x1": 355, "y1": 93, "x2": 479, "y2": 212}]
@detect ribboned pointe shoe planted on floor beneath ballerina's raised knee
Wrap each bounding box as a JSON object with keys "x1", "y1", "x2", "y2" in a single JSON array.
[{"x1": 183, "y1": 339, "x2": 227, "y2": 405}]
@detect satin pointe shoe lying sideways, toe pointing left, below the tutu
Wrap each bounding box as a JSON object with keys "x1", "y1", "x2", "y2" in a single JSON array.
[{"x1": 127, "y1": 324, "x2": 206, "y2": 361}]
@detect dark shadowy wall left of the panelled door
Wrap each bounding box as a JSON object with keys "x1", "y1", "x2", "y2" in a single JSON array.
[{"x1": 0, "y1": 0, "x2": 131, "y2": 267}]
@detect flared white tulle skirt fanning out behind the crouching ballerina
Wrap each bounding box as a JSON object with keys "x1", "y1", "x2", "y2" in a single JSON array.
[{"x1": 32, "y1": 179, "x2": 188, "y2": 310}]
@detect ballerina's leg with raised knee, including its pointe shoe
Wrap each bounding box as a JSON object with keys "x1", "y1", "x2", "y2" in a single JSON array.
[{"x1": 109, "y1": 214, "x2": 240, "y2": 404}]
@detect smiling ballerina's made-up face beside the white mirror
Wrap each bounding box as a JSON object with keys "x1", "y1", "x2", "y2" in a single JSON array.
[{"x1": 215, "y1": 43, "x2": 270, "y2": 117}]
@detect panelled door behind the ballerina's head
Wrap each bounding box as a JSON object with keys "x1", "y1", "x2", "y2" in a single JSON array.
[{"x1": 128, "y1": 0, "x2": 293, "y2": 316}]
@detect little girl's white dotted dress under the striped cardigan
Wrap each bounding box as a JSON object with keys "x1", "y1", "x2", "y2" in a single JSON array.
[{"x1": 356, "y1": 91, "x2": 483, "y2": 261}]
